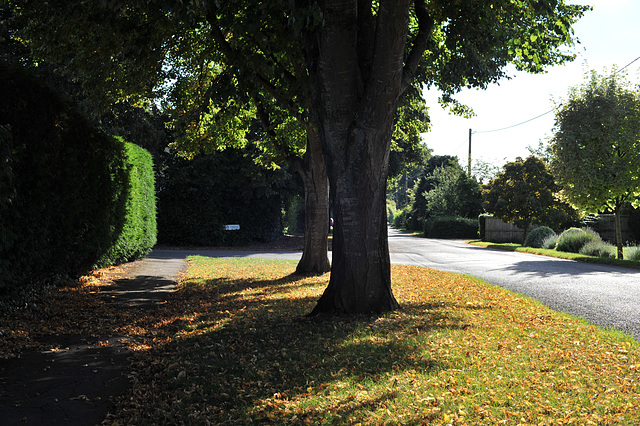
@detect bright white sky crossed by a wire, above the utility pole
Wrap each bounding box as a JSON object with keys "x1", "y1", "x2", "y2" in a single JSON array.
[{"x1": 422, "y1": 0, "x2": 640, "y2": 169}]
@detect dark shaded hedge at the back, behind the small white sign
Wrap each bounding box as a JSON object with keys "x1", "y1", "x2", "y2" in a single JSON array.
[{"x1": 158, "y1": 149, "x2": 283, "y2": 246}]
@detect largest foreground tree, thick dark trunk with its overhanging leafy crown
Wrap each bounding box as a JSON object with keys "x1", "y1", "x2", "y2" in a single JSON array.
[{"x1": 8, "y1": 0, "x2": 586, "y2": 314}]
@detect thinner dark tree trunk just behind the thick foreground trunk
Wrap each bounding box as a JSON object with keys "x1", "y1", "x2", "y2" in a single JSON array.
[{"x1": 296, "y1": 128, "x2": 331, "y2": 274}]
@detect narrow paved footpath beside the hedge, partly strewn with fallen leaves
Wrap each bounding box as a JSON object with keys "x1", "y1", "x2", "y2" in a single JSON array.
[{"x1": 0, "y1": 258, "x2": 187, "y2": 426}]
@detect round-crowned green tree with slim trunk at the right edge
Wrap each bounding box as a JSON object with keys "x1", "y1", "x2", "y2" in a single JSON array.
[{"x1": 551, "y1": 71, "x2": 640, "y2": 259}]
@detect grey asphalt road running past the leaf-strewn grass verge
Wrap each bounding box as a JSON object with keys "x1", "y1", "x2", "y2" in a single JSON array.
[{"x1": 149, "y1": 229, "x2": 640, "y2": 340}]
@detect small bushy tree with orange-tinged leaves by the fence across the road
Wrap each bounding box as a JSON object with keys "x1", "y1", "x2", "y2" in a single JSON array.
[{"x1": 483, "y1": 156, "x2": 575, "y2": 242}]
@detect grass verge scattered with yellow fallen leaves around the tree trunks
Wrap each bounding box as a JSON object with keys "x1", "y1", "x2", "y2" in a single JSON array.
[{"x1": 108, "y1": 257, "x2": 640, "y2": 425}]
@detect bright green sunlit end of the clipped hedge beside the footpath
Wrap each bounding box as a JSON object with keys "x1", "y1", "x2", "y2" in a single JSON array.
[{"x1": 97, "y1": 141, "x2": 157, "y2": 266}]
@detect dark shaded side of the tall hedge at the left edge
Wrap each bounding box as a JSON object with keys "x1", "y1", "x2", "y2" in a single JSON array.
[{"x1": 0, "y1": 64, "x2": 127, "y2": 293}]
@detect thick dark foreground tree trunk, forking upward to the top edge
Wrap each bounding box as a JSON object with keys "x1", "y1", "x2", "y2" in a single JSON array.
[{"x1": 307, "y1": 0, "x2": 416, "y2": 315}]
